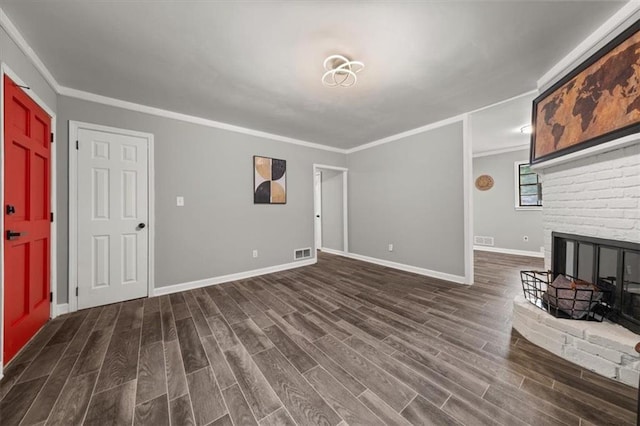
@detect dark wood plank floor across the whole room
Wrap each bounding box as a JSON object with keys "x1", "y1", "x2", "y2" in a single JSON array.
[{"x1": 0, "y1": 253, "x2": 636, "y2": 426}]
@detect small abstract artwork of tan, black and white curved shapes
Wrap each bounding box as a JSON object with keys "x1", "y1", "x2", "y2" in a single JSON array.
[{"x1": 253, "y1": 155, "x2": 287, "y2": 204}]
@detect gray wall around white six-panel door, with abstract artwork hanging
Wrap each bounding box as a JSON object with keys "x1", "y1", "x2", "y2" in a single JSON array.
[{"x1": 57, "y1": 96, "x2": 346, "y2": 303}]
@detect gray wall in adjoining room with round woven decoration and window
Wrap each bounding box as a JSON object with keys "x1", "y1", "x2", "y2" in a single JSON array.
[{"x1": 473, "y1": 149, "x2": 544, "y2": 252}]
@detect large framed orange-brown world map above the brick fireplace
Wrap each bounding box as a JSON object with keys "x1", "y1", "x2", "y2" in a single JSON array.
[{"x1": 530, "y1": 21, "x2": 640, "y2": 164}]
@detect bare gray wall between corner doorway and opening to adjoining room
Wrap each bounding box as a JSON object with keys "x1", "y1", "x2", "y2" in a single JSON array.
[{"x1": 347, "y1": 122, "x2": 464, "y2": 276}]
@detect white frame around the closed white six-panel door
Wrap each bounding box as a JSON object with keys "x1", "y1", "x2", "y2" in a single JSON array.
[{"x1": 69, "y1": 120, "x2": 156, "y2": 312}]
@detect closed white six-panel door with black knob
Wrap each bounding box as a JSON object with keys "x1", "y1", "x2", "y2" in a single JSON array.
[{"x1": 76, "y1": 129, "x2": 149, "y2": 309}]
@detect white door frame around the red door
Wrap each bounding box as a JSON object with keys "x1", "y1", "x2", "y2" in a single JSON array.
[{"x1": 0, "y1": 62, "x2": 58, "y2": 379}]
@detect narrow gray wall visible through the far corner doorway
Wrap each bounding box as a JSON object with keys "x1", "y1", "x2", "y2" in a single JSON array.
[{"x1": 321, "y1": 170, "x2": 344, "y2": 251}]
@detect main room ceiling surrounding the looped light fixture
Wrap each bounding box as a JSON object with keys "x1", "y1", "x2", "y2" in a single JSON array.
[{"x1": 0, "y1": 0, "x2": 624, "y2": 148}]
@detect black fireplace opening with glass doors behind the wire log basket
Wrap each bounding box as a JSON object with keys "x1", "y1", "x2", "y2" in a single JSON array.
[{"x1": 551, "y1": 232, "x2": 640, "y2": 333}]
